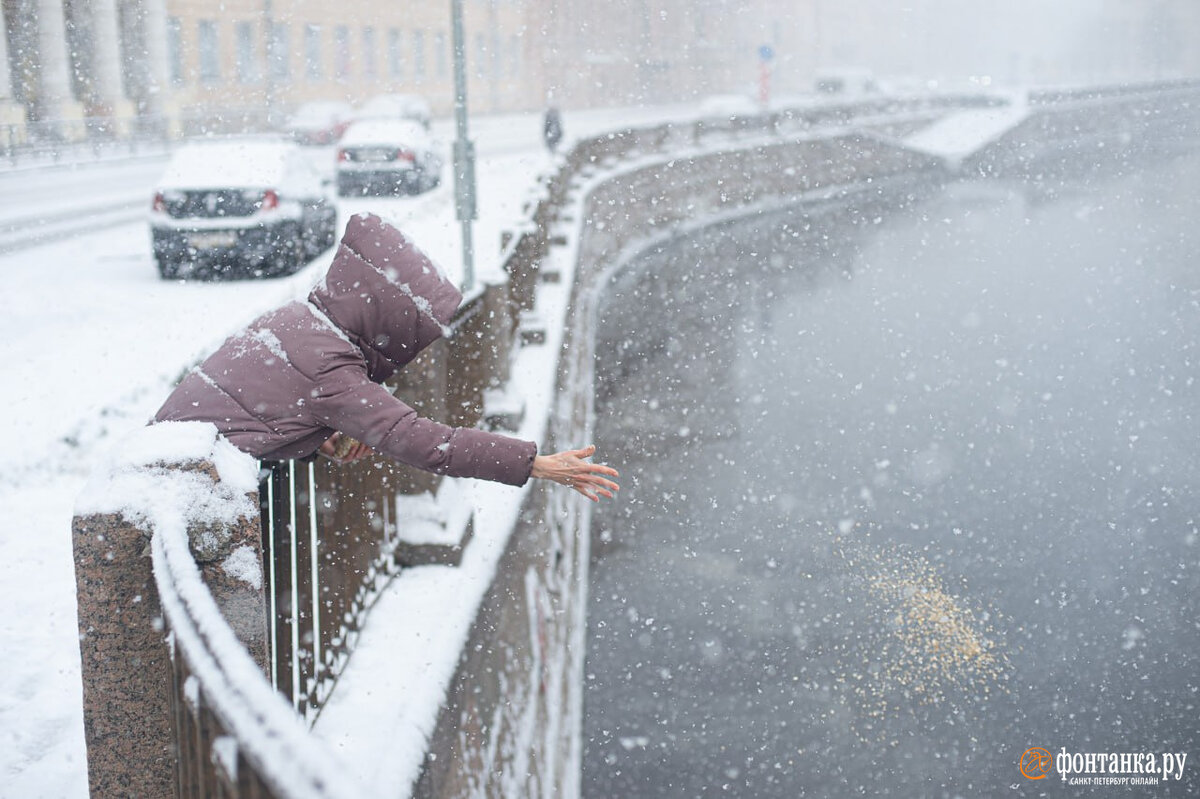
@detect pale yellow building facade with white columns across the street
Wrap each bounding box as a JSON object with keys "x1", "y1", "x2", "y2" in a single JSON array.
[{"x1": 0, "y1": 0, "x2": 808, "y2": 140}]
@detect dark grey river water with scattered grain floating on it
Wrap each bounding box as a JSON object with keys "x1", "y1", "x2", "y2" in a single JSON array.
[{"x1": 583, "y1": 156, "x2": 1200, "y2": 798}]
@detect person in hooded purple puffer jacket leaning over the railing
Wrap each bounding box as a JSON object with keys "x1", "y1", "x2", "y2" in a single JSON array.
[{"x1": 154, "y1": 214, "x2": 618, "y2": 500}]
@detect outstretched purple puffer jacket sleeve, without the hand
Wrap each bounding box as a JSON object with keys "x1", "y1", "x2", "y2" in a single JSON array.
[{"x1": 312, "y1": 365, "x2": 538, "y2": 486}]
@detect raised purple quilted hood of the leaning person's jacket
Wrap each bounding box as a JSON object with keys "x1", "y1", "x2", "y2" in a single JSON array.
[{"x1": 308, "y1": 214, "x2": 462, "y2": 383}]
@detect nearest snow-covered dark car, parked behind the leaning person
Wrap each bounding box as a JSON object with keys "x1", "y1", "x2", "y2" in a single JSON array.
[{"x1": 150, "y1": 138, "x2": 337, "y2": 278}]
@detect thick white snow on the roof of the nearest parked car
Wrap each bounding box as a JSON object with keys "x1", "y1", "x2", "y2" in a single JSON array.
[{"x1": 158, "y1": 139, "x2": 296, "y2": 188}]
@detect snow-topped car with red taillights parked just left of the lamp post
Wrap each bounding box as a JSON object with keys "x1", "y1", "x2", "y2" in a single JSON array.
[{"x1": 336, "y1": 120, "x2": 442, "y2": 197}]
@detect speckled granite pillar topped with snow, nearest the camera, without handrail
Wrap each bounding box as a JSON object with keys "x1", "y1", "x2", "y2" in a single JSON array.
[{"x1": 72, "y1": 431, "x2": 269, "y2": 797}]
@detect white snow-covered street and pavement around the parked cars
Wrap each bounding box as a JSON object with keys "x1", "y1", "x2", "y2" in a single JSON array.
[{"x1": 0, "y1": 109, "x2": 686, "y2": 799}]
